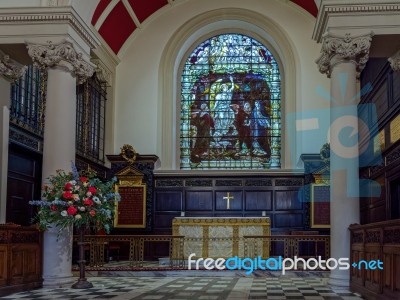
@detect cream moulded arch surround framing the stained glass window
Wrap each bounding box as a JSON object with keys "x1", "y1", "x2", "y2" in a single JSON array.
[{"x1": 157, "y1": 8, "x2": 299, "y2": 172}]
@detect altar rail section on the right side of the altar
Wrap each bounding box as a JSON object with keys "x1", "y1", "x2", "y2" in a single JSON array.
[{"x1": 243, "y1": 235, "x2": 330, "y2": 259}]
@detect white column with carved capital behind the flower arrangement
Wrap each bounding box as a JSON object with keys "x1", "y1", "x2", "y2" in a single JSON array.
[{"x1": 28, "y1": 41, "x2": 93, "y2": 287}]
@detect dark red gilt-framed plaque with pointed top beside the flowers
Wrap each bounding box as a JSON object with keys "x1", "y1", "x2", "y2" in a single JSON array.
[{"x1": 114, "y1": 166, "x2": 146, "y2": 228}]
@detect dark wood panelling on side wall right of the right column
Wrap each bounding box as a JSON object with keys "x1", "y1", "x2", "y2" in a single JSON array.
[{"x1": 359, "y1": 58, "x2": 400, "y2": 224}]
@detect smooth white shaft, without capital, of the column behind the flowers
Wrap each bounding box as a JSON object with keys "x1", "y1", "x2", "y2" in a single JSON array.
[{"x1": 42, "y1": 67, "x2": 76, "y2": 286}]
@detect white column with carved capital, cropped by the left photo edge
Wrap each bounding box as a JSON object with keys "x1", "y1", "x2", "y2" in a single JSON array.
[{"x1": 0, "y1": 51, "x2": 26, "y2": 224}]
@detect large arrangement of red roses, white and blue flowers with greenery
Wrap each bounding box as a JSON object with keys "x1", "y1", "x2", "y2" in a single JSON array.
[{"x1": 30, "y1": 165, "x2": 119, "y2": 232}]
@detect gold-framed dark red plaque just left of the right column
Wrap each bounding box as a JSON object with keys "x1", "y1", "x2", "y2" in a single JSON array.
[{"x1": 311, "y1": 184, "x2": 331, "y2": 228}]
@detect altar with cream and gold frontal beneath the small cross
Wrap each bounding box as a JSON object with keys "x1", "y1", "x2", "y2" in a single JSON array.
[{"x1": 172, "y1": 217, "x2": 271, "y2": 259}]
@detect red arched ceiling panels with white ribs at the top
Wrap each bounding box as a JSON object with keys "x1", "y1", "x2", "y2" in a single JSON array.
[{"x1": 91, "y1": 0, "x2": 318, "y2": 54}]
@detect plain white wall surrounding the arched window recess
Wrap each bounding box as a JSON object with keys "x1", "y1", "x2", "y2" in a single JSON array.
[{"x1": 114, "y1": 0, "x2": 329, "y2": 169}]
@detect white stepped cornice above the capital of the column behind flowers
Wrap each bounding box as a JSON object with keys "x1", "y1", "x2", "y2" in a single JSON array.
[{"x1": 0, "y1": 6, "x2": 100, "y2": 50}]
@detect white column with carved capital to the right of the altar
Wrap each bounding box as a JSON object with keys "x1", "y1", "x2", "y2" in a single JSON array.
[{"x1": 317, "y1": 34, "x2": 372, "y2": 287}]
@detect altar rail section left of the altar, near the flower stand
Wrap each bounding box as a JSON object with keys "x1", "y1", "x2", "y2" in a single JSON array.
[{"x1": 74, "y1": 235, "x2": 184, "y2": 268}]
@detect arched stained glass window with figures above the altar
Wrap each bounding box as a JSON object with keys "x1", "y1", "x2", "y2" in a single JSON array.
[{"x1": 180, "y1": 34, "x2": 281, "y2": 170}]
